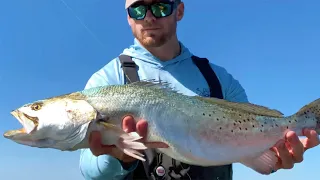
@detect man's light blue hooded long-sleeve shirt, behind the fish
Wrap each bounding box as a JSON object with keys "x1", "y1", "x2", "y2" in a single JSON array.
[{"x1": 80, "y1": 39, "x2": 248, "y2": 180}]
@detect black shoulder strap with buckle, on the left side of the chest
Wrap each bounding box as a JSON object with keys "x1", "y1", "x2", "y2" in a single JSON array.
[{"x1": 119, "y1": 55, "x2": 139, "y2": 83}]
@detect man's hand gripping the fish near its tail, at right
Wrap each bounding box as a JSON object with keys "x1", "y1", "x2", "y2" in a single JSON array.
[{"x1": 272, "y1": 129, "x2": 320, "y2": 171}]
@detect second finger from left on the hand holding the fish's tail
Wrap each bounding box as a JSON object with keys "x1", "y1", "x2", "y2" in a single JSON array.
[{"x1": 286, "y1": 131, "x2": 304, "y2": 162}]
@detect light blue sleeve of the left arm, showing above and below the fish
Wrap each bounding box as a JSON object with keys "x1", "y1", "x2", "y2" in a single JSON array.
[{"x1": 79, "y1": 64, "x2": 138, "y2": 180}]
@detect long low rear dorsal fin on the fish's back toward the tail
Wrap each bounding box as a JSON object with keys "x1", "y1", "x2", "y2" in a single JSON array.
[{"x1": 196, "y1": 96, "x2": 283, "y2": 118}]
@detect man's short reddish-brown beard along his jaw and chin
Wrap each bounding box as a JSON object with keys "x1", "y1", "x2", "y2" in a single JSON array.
[{"x1": 133, "y1": 24, "x2": 176, "y2": 47}]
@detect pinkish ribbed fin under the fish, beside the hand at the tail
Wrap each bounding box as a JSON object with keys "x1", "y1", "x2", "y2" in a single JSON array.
[{"x1": 240, "y1": 150, "x2": 278, "y2": 175}]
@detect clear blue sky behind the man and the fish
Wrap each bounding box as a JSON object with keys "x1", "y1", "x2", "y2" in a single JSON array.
[{"x1": 0, "y1": 0, "x2": 320, "y2": 180}]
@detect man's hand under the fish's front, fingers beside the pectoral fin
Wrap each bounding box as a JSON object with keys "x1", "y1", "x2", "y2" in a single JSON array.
[{"x1": 89, "y1": 116, "x2": 168, "y2": 163}]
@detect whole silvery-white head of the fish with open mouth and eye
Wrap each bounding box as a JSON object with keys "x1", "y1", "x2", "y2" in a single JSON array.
[{"x1": 4, "y1": 93, "x2": 97, "y2": 150}]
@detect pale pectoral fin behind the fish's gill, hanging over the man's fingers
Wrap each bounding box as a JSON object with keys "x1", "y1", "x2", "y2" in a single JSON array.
[{"x1": 98, "y1": 121, "x2": 147, "y2": 161}]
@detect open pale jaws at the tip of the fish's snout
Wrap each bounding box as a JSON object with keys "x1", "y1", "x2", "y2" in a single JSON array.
[{"x1": 4, "y1": 110, "x2": 39, "y2": 138}]
